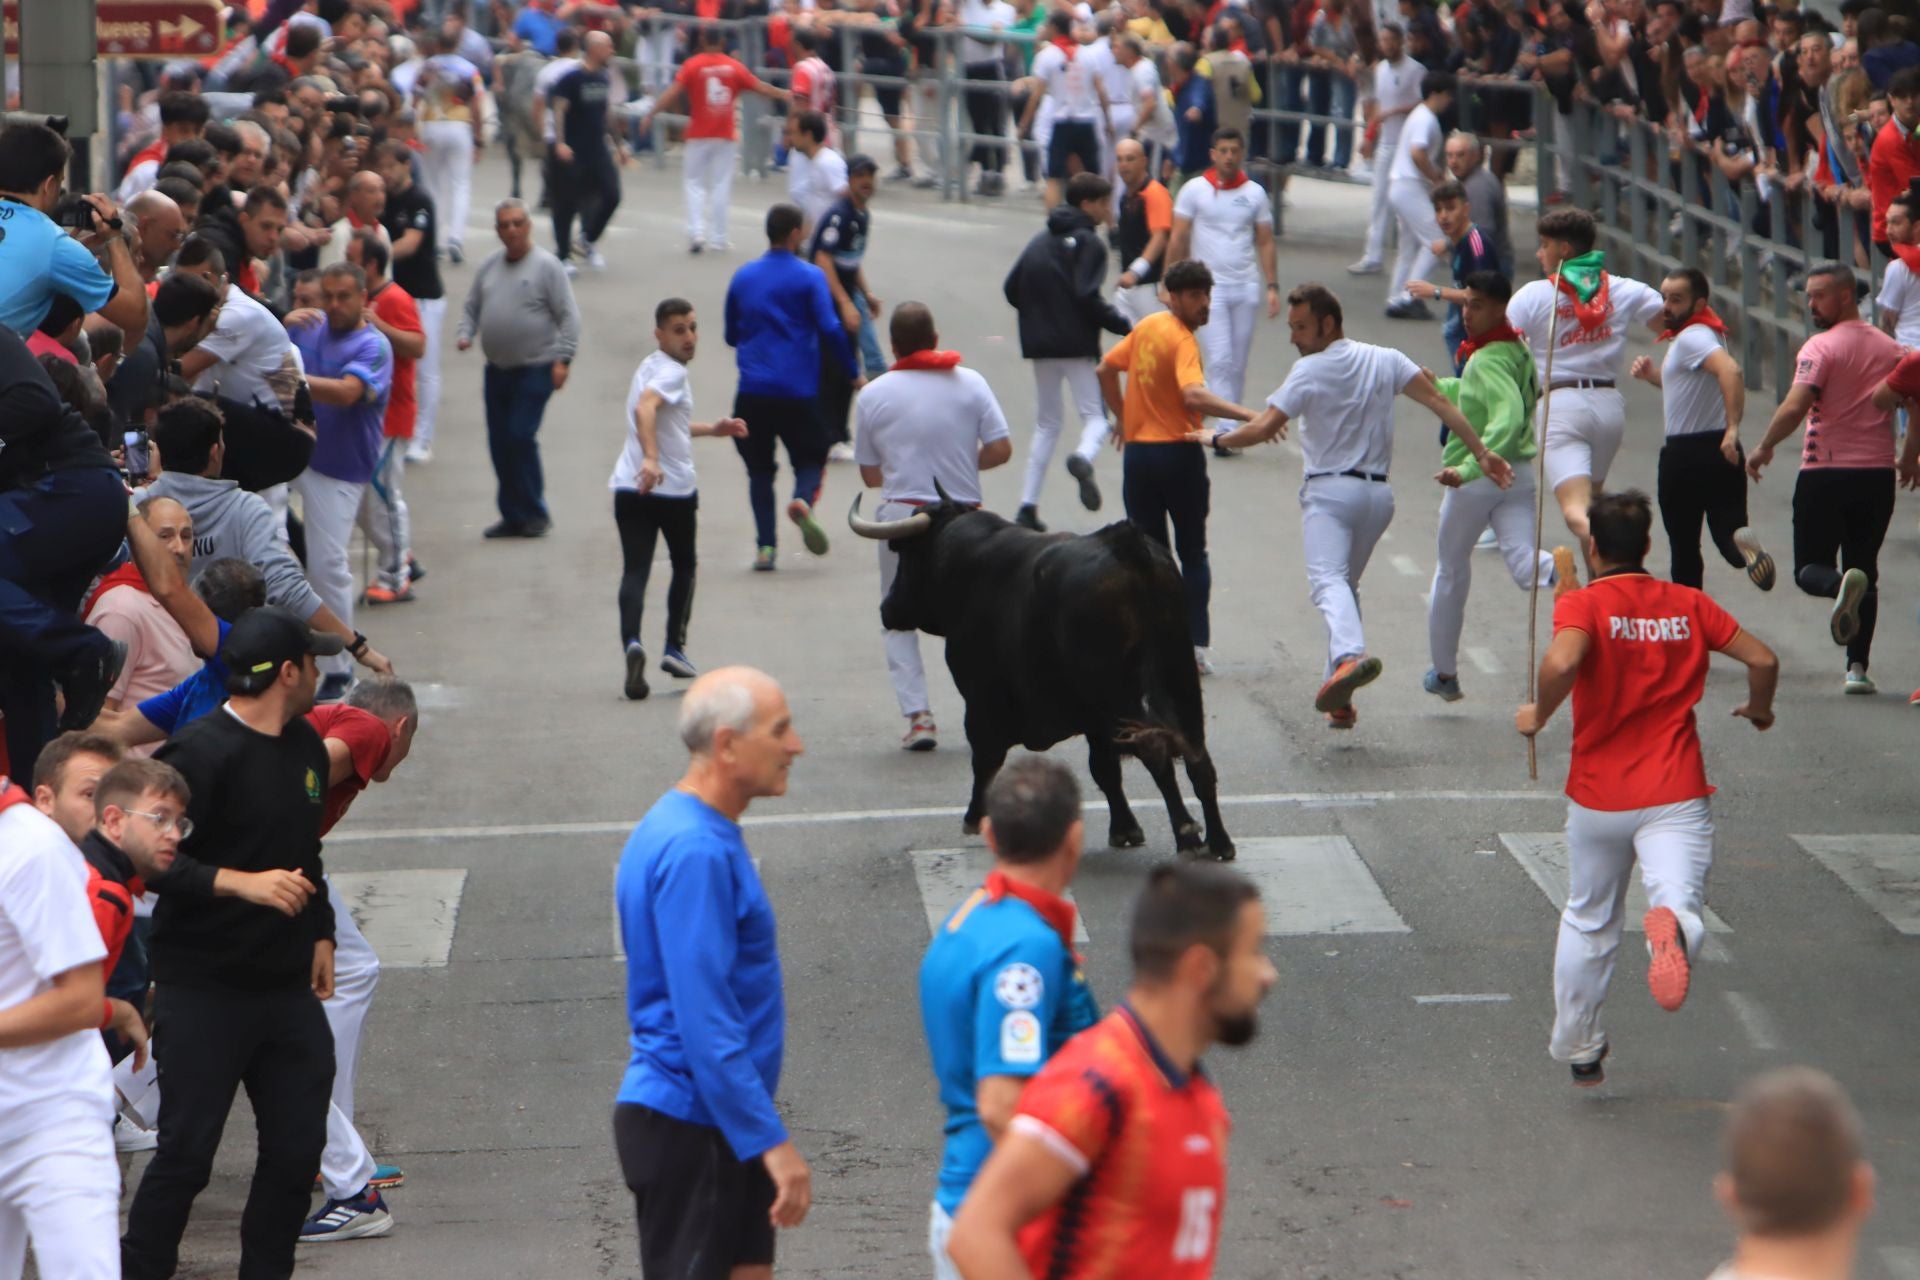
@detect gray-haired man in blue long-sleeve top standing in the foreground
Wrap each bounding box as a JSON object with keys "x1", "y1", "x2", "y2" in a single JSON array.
[{"x1": 612, "y1": 666, "x2": 812, "y2": 1280}]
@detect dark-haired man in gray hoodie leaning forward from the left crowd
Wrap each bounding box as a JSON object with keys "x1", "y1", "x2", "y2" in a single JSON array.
[{"x1": 142, "y1": 399, "x2": 394, "y2": 676}]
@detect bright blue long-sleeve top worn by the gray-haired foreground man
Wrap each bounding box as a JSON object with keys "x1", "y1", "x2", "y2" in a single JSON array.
[{"x1": 614, "y1": 791, "x2": 787, "y2": 1159}]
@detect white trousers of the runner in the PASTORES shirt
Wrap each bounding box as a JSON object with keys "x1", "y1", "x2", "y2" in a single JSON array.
[{"x1": 1548, "y1": 796, "x2": 1713, "y2": 1063}]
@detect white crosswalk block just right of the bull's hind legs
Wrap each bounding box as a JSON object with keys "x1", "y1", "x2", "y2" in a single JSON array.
[{"x1": 1233, "y1": 835, "x2": 1411, "y2": 938}]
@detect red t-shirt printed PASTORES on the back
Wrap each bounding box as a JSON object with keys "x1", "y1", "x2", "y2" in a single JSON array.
[{"x1": 1553, "y1": 572, "x2": 1740, "y2": 812}]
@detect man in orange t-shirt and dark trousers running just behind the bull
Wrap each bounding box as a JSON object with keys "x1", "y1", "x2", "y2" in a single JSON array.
[{"x1": 1100, "y1": 259, "x2": 1254, "y2": 676}]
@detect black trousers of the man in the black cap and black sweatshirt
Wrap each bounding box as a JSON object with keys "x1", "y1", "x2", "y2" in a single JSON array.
[{"x1": 121, "y1": 983, "x2": 334, "y2": 1280}]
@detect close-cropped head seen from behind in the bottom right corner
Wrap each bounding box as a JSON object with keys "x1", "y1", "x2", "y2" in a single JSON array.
[{"x1": 1713, "y1": 1067, "x2": 1874, "y2": 1280}]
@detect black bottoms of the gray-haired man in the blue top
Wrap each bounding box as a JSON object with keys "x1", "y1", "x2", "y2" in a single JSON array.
[{"x1": 612, "y1": 1102, "x2": 774, "y2": 1280}]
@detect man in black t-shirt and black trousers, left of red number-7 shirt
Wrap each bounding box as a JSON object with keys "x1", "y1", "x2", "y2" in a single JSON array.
[{"x1": 547, "y1": 31, "x2": 626, "y2": 273}]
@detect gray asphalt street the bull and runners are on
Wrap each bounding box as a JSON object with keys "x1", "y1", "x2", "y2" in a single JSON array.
[{"x1": 134, "y1": 147, "x2": 1920, "y2": 1280}]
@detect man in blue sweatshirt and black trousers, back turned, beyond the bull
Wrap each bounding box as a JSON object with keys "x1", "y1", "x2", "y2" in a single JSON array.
[{"x1": 726, "y1": 203, "x2": 866, "y2": 572}]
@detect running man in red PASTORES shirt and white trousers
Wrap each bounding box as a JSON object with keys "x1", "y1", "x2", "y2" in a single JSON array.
[{"x1": 1513, "y1": 489, "x2": 1780, "y2": 1088}]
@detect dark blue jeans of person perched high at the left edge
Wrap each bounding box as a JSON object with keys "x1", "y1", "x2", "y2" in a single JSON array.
[{"x1": 0, "y1": 466, "x2": 127, "y2": 777}]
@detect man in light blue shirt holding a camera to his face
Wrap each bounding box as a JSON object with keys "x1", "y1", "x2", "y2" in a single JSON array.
[{"x1": 0, "y1": 125, "x2": 146, "y2": 342}]
